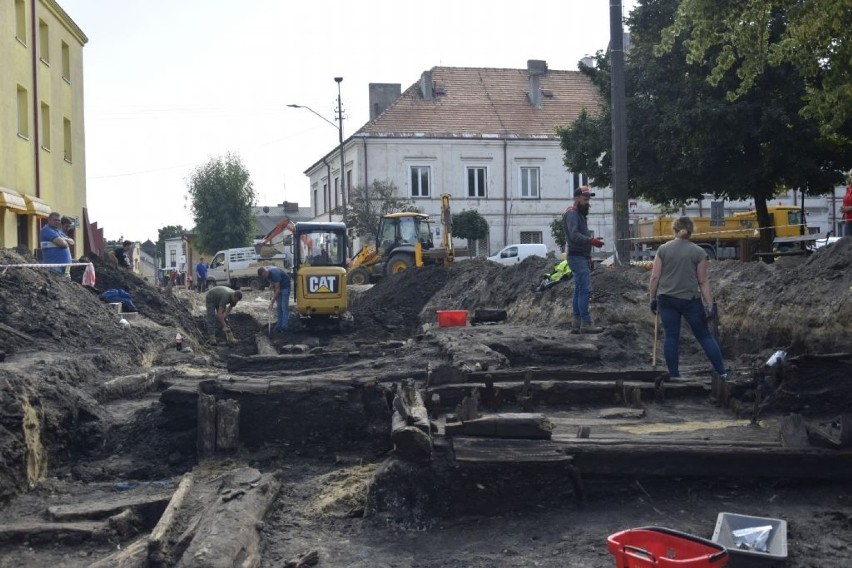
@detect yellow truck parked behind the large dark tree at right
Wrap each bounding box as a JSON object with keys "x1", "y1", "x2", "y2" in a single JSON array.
[{"x1": 634, "y1": 205, "x2": 808, "y2": 260}]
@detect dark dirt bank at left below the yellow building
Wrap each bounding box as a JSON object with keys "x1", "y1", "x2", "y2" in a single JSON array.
[{"x1": 0, "y1": 249, "x2": 206, "y2": 500}]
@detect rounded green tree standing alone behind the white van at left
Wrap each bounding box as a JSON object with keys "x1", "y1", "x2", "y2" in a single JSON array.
[{"x1": 187, "y1": 153, "x2": 255, "y2": 251}]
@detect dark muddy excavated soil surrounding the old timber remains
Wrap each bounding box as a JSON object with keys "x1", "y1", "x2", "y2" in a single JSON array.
[{"x1": 0, "y1": 239, "x2": 852, "y2": 567}]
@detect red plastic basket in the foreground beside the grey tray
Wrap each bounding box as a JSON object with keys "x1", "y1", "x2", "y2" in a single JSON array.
[{"x1": 606, "y1": 527, "x2": 728, "y2": 568}]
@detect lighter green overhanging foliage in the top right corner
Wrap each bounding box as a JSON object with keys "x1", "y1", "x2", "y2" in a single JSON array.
[{"x1": 657, "y1": 0, "x2": 852, "y2": 141}]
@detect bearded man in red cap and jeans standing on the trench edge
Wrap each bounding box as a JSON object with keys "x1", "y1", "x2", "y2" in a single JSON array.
[{"x1": 562, "y1": 185, "x2": 603, "y2": 333}]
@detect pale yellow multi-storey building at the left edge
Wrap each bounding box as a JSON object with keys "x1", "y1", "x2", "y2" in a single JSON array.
[{"x1": 0, "y1": 0, "x2": 88, "y2": 257}]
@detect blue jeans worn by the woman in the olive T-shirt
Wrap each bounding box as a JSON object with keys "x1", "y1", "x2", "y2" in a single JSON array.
[{"x1": 657, "y1": 294, "x2": 725, "y2": 377}]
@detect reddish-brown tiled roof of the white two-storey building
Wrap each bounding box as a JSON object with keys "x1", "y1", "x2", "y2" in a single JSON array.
[{"x1": 355, "y1": 67, "x2": 599, "y2": 138}]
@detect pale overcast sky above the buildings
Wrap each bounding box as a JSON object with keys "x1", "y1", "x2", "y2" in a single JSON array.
[{"x1": 59, "y1": 0, "x2": 635, "y2": 241}]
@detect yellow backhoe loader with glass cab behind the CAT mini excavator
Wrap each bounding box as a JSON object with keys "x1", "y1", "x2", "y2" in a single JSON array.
[{"x1": 347, "y1": 193, "x2": 455, "y2": 284}]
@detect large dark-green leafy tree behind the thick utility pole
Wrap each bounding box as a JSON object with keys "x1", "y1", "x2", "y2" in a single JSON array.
[{"x1": 560, "y1": 0, "x2": 848, "y2": 250}]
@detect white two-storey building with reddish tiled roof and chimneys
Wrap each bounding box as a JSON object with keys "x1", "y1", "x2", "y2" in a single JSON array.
[{"x1": 305, "y1": 60, "x2": 612, "y2": 254}]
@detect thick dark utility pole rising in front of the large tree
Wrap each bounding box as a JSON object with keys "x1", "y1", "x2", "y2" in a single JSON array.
[{"x1": 609, "y1": 0, "x2": 631, "y2": 264}]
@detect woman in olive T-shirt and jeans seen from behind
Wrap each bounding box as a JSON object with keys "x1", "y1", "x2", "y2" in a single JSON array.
[{"x1": 650, "y1": 217, "x2": 728, "y2": 380}]
